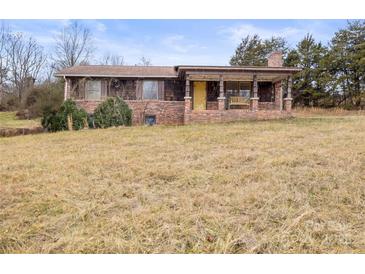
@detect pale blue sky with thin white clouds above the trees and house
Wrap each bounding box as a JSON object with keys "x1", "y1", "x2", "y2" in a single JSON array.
[{"x1": 2, "y1": 19, "x2": 347, "y2": 65}]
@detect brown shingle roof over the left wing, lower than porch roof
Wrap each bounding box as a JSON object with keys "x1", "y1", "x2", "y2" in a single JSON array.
[{"x1": 55, "y1": 65, "x2": 177, "y2": 78}]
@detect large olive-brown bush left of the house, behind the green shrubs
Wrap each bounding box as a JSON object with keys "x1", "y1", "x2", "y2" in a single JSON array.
[{"x1": 19, "y1": 81, "x2": 64, "y2": 118}]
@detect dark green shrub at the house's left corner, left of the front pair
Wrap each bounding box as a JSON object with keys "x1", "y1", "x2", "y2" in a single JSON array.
[{"x1": 42, "y1": 99, "x2": 87, "y2": 132}]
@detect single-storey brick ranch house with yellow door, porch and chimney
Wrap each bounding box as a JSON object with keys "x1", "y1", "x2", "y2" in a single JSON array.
[{"x1": 56, "y1": 52, "x2": 300, "y2": 125}]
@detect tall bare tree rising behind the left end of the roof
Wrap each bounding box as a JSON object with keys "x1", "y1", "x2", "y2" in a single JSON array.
[{"x1": 53, "y1": 21, "x2": 94, "y2": 69}]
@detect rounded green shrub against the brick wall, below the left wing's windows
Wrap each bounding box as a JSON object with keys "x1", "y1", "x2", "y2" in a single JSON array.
[{"x1": 93, "y1": 97, "x2": 132, "y2": 128}]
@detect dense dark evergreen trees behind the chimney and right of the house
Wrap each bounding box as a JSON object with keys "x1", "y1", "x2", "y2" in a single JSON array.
[{"x1": 230, "y1": 20, "x2": 365, "y2": 109}]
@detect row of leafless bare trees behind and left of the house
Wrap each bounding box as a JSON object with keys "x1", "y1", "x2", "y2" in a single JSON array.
[{"x1": 0, "y1": 20, "x2": 151, "y2": 104}]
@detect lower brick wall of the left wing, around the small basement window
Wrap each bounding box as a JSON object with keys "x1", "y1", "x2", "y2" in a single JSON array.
[{"x1": 76, "y1": 100, "x2": 185, "y2": 125}]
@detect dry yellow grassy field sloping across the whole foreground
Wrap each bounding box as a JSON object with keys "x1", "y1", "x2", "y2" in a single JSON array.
[{"x1": 0, "y1": 116, "x2": 365, "y2": 253}]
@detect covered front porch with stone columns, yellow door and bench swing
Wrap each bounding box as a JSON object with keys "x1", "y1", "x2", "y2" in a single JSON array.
[{"x1": 178, "y1": 67, "x2": 294, "y2": 115}]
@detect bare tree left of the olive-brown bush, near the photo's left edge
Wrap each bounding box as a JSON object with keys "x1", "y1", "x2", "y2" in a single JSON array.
[{"x1": 7, "y1": 33, "x2": 45, "y2": 100}]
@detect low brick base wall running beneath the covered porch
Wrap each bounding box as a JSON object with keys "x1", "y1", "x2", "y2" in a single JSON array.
[{"x1": 185, "y1": 109, "x2": 292, "y2": 124}]
